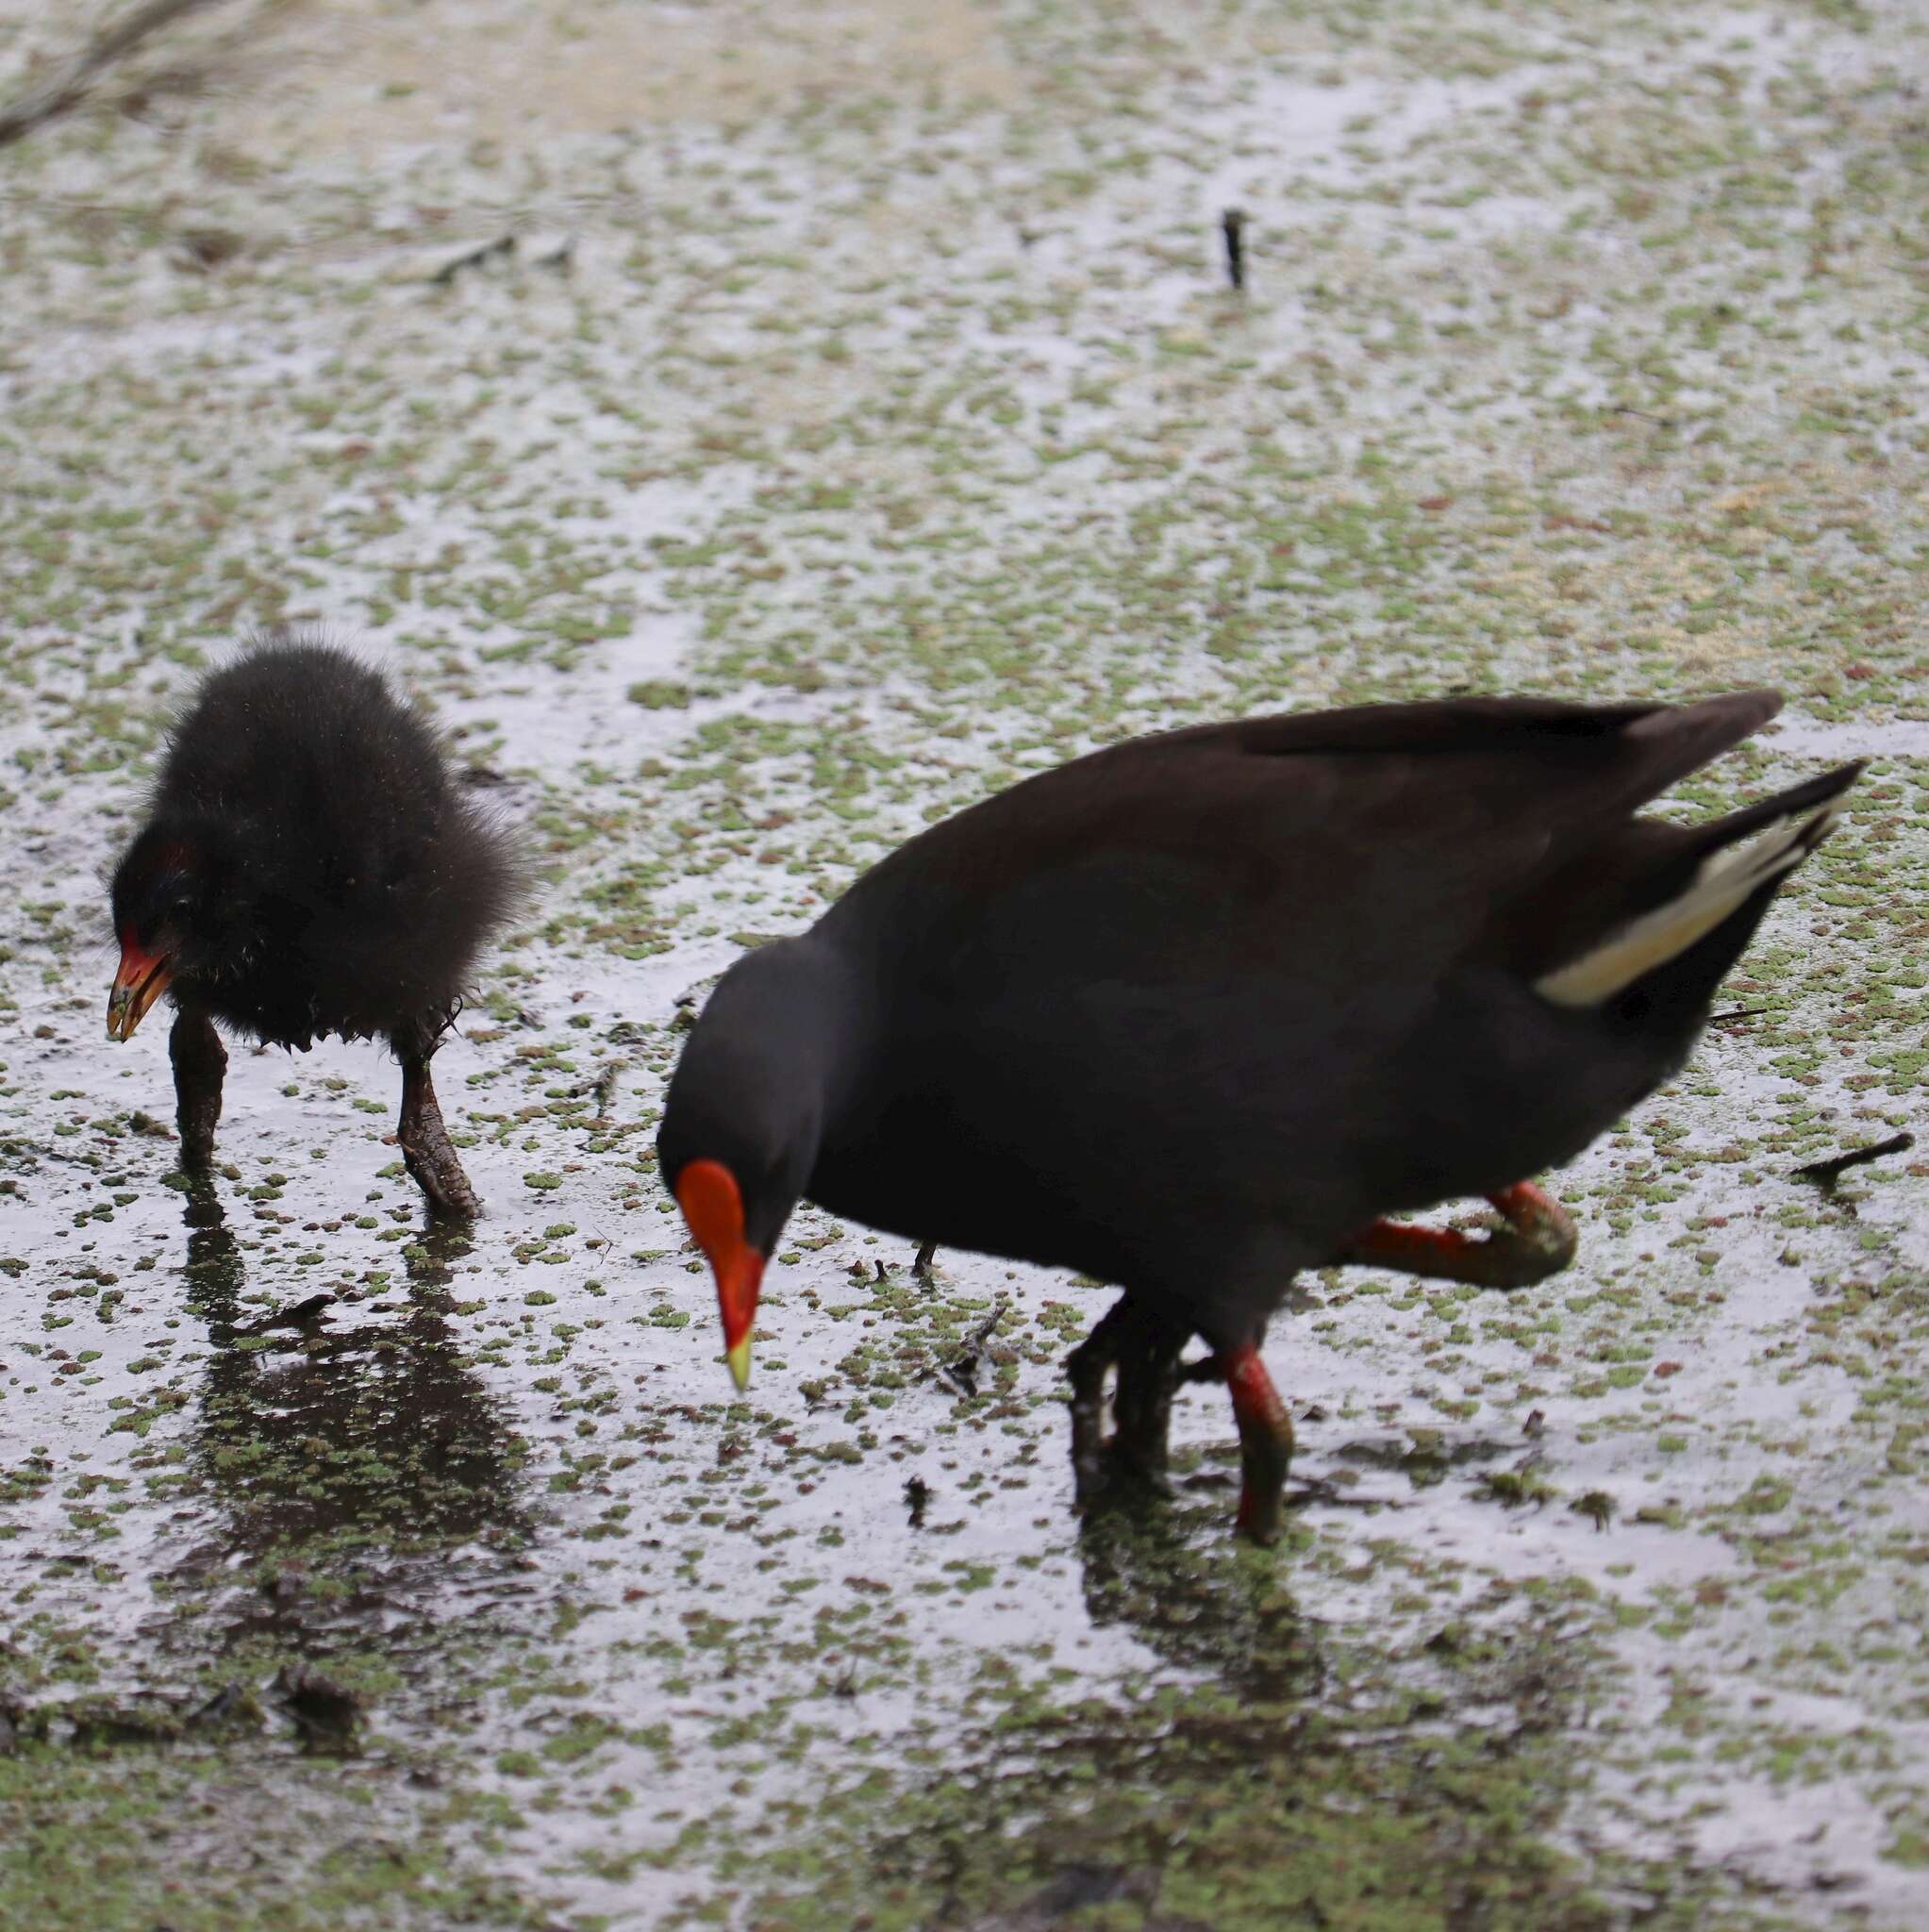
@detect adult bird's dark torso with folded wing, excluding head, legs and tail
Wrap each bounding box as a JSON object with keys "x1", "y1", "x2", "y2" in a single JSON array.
[{"x1": 813, "y1": 695, "x2": 1774, "y2": 1310}]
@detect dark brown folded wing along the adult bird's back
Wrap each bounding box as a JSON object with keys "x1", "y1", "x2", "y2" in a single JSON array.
[{"x1": 834, "y1": 691, "x2": 1780, "y2": 1003}]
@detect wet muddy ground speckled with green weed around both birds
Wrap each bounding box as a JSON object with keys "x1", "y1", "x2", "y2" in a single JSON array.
[{"x1": 0, "y1": 0, "x2": 1929, "y2": 1932}]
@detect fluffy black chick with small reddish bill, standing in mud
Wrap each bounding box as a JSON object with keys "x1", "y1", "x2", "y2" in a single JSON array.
[{"x1": 108, "y1": 632, "x2": 525, "y2": 1215}]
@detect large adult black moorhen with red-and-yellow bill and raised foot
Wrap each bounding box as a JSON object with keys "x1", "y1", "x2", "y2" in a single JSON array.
[{"x1": 657, "y1": 691, "x2": 1859, "y2": 1540}]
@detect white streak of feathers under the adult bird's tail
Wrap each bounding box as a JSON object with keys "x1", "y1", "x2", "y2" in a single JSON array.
[{"x1": 1533, "y1": 765, "x2": 1861, "y2": 1007}]
